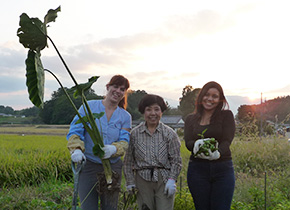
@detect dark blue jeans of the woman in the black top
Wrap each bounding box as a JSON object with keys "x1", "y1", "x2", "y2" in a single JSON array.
[{"x1": 187, "y1": 160, "x2": 235, "y2": 210}]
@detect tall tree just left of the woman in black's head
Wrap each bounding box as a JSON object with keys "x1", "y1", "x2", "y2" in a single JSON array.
[{"x1": 178, "y1": 85, "x2": 200, "y2": 119}]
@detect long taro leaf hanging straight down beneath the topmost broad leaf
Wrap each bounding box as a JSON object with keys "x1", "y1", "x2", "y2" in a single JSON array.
[{"x1": 25, "y1": 50, "x2": 44, "y2": 107}]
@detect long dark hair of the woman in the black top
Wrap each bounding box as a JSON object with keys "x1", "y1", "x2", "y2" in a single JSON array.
[{"x1": 194, "y1": 81, "x2": 229, "y2": 121}]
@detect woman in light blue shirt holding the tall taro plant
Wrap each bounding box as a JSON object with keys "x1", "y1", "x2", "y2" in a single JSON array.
[{"x1": 67, "y1": 75, "x2": 132, "y2": 210}]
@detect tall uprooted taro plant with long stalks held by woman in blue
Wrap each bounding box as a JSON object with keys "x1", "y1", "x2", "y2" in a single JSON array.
[{"x1": 17, "y1": 6, "x2": 112, "y2": 186}]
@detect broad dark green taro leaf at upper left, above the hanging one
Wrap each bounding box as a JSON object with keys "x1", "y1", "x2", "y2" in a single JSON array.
[{"x1": 17, "y1": 13, "x2": 47, "y2": 52}]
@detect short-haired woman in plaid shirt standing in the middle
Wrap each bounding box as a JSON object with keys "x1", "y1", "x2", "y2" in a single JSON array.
[{"x1": 124, "y1": 94, "x2": 181, "y2": 210}]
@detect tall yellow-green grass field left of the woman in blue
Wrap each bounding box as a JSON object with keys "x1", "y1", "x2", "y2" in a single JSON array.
[{"x1": 0, "y1": 135, "x2": 72, "y2": 186}]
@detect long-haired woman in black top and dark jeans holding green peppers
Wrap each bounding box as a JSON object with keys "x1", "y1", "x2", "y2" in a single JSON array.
[{"x1": 184, "y1": 82, "x2": 235, "y2": 210}]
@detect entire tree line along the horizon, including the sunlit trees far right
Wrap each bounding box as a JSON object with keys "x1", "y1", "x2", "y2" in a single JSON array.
[{"x1": 0, "y1": 85, "x2": 290, "y2": 130}]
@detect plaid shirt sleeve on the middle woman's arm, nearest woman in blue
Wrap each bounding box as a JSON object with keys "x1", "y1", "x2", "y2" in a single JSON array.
[{"x1": 124, "y1": 133, "x2": 135, "y2": 185}]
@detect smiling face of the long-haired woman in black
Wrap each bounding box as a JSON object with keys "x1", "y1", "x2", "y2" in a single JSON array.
[{"x1": 202, "y1": 88, "x2": 220, "y2": 111}]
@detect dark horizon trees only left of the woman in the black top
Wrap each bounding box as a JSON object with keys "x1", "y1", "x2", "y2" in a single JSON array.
[{"x1": 0, "y1": 86, "x2": 199, "y2": 124}]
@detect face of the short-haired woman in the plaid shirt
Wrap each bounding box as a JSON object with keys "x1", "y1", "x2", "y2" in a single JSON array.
[{"x1": 144, "y1": 104, "x2": 162, "y2": 127}]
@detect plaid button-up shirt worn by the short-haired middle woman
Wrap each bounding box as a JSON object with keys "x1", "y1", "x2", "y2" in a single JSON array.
[{"x1": 124, "y1": 122, "x2": 182, "y2": 185}]
